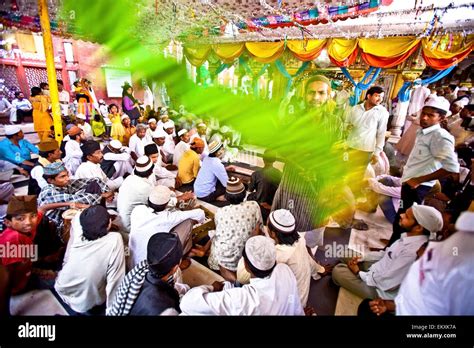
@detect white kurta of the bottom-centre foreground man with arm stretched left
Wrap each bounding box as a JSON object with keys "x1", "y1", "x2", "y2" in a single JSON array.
[{"x1": 180, "y1": 264, "x2": 304, "y2": 315}]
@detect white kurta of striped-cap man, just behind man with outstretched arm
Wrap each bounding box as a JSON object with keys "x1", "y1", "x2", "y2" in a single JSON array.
[{"x1": 117, "y1": 174, "x2": 153, "y2": 232}]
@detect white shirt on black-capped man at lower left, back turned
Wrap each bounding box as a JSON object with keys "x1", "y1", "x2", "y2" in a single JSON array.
[{"x1": 54, "y1": 214, "x2": 125, "y2": 313}]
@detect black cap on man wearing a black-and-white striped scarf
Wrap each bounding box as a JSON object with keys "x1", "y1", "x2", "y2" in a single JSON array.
[{"x1": 147, "y1": 232, "x2": 183, "y2": 278}]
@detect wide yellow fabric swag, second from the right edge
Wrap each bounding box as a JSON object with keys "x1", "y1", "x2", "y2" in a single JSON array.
[{"x1": 359, "y1": 36, "x2": 420, "y2": 58}]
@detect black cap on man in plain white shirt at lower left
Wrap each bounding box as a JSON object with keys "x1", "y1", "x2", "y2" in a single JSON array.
[{"x1": 79, "y1": 205, "x2": 110, "y2": 240}]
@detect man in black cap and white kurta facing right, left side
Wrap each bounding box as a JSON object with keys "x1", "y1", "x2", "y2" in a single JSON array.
[{"x1": 75, "y1": 140, "x2": 123, "y2": 191}]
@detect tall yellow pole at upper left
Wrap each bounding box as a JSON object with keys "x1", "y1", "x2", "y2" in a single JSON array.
[{"x1": 38, "y1": 0, "x2": 63, "y2": 143}]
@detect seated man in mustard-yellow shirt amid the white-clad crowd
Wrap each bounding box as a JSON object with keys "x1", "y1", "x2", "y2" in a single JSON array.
[{"x1": 178, "y1": 138, "x2": 204, "y2": 191}]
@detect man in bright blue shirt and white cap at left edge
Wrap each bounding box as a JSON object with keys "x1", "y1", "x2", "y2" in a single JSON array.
[{"x1": 0, "y1": 125, "x2": 39, "y2": 172}]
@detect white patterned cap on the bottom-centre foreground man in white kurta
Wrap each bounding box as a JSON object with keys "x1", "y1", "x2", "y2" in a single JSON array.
[{"x1": 245, "y1": 236, "x2": 276, "y2": 271}]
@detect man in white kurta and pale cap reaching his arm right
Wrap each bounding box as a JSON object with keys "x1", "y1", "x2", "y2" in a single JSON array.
[{"x1": 128, "y1": 186, "x2": 205, "y2": 267}]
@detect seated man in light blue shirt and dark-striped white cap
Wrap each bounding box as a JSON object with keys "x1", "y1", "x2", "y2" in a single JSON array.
[{"x1": 194, "y1": 140, "x2": 235, "y2": 203}]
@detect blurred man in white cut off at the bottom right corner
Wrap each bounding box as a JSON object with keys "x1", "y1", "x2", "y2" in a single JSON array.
[{"x1": 395, "y1": 211, "x2": 474, "y2": 315}]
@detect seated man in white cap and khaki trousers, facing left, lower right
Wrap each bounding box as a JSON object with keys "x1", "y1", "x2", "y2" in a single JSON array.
[{"x1": 332, "y1": 204, "x2": 436, "y2": 300}]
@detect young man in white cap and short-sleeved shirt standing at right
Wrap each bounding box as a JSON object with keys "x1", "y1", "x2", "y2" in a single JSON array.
[{"x1": 388, "y1": 96, "x2": 459, "y2": 245}]
